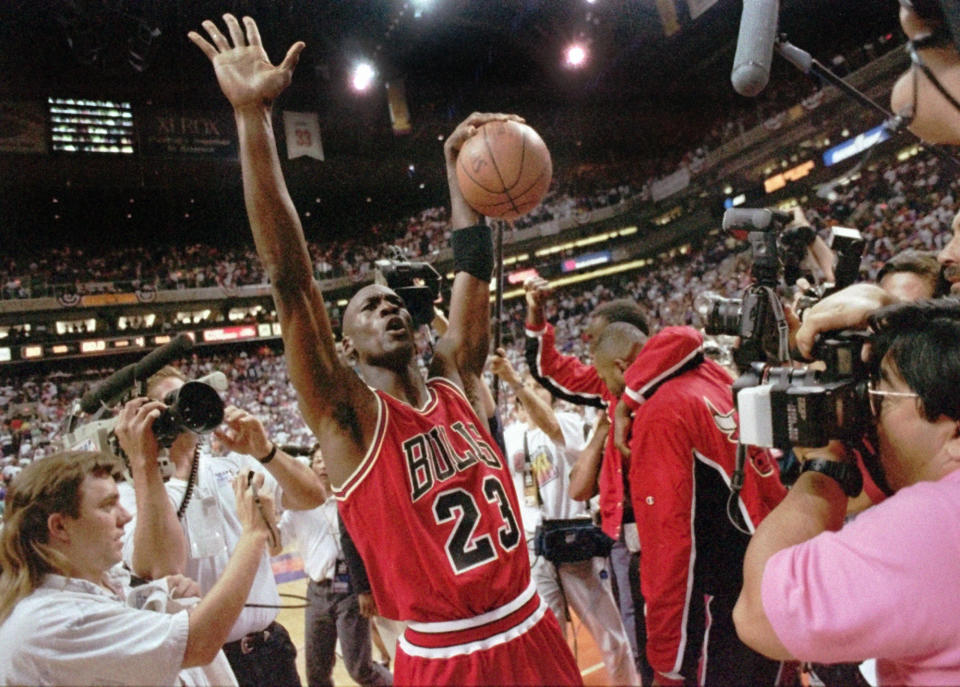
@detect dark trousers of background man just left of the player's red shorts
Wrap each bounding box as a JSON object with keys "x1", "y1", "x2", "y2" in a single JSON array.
[{"x1": 304, "y1": 580, "x2": 393, "y2": 687}]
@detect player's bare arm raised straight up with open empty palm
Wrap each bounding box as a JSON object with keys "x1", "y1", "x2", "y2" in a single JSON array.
[{"x1": 189, "y1": 14, "x2": 376, "y2": 484}]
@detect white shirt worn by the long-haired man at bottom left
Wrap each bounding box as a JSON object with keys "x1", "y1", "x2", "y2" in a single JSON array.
[{"x1": 0, "y1": 575, "x2": 189, "y2": 685}]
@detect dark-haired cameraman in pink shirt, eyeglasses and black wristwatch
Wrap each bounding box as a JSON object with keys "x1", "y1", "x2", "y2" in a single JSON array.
[{"x1": 734, "y1": 298, "x2": 960, "y2": 685}]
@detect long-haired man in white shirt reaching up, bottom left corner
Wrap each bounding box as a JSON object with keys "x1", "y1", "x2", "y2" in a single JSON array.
[{"x1": 0, "y1": 451, "x2": 273, "y2": 685}]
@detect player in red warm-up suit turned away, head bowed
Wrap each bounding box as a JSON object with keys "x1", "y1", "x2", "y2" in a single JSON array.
[{"x1": 594, "y1": 323, "x2": 784, "y2": 685}]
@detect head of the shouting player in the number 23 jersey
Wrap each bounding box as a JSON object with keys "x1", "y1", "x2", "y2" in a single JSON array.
[{"x1": 343, "y1": 284, "x2": 416, "y2": 367}]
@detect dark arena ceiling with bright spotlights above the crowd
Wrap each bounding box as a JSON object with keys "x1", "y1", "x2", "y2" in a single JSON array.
[{"x1": 0, "y1": 0, "x2": 899, "y2": 245}]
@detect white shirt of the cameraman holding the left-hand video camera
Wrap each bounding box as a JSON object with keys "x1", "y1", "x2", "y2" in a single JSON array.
[{"x1": 117, "y1": 453, "x2": 280, "y2": 642}]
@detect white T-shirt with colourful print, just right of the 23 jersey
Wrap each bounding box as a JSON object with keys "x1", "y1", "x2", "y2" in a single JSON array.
[{"x1": 503, "y1": 411, "x2": 589, "y2": 539}]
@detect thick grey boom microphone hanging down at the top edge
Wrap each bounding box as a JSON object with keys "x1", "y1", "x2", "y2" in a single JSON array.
[{"x1": 730, "y1": 0, "x2": 780, "y2": 98}]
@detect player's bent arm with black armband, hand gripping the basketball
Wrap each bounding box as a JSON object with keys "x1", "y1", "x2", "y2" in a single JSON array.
[{"x1": 431, "y1": 112, "x2": 523, "y2": 417}]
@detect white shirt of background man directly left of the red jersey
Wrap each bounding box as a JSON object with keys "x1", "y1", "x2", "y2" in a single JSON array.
[{"x1": 277, "y1": 497, "x2": 343, "y2": 582}]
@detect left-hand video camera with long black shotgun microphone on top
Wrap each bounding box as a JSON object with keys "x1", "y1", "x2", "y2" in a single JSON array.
[{"x1": 61, "y1": 334, "x2": 227, "y2": 476}]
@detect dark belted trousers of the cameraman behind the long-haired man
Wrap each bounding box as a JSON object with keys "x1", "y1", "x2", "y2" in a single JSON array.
[{"x1": 223, "y1": 622, "x2": 301, "y2": 687}]
